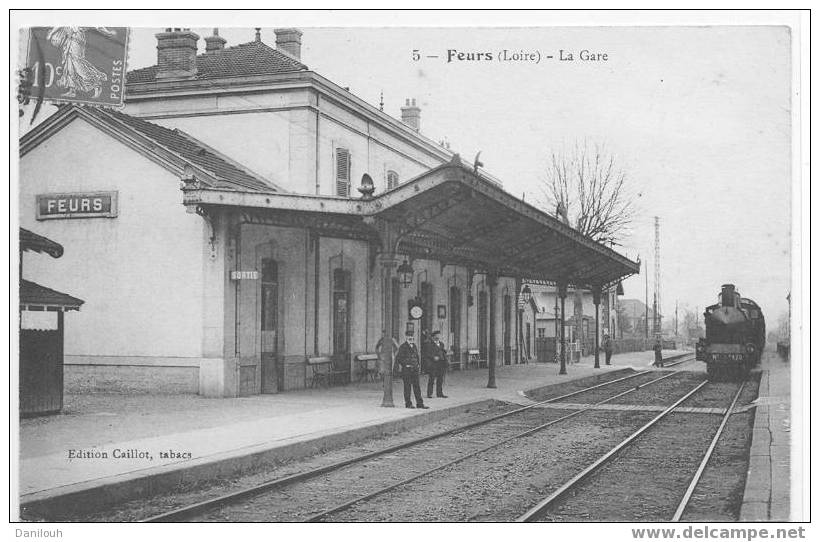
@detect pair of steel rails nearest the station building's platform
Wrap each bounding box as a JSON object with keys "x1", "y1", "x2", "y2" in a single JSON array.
[{"x1": 142, "y1": 364, "x2": 692, "y2": 522}]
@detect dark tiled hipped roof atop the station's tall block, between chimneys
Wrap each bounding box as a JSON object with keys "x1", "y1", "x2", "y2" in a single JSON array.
[{"x1": 126, "y1": 41, "x2": 307, "y2": 83}]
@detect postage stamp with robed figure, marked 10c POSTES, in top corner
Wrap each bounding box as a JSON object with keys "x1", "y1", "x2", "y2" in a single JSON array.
[{"x1": 27, "y1": 26, "x2": 128, "y2": 106}]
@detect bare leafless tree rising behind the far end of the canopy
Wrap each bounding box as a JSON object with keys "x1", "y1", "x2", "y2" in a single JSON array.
[{"x1": 542, "y1": 141, "x2": 639, "y2": 245}]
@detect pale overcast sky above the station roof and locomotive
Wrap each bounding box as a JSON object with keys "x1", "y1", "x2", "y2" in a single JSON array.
[{"x1": 16, "y1": 17, "x2": 792, "y2": 323}]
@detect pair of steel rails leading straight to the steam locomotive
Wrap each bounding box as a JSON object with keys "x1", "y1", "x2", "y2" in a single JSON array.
[{"x1": 516, "y1": 380, "x2": 745, "y2": 522}]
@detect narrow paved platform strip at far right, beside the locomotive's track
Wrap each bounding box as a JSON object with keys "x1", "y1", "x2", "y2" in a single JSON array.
[{"x1": 740, "y1": 351, "x2": 791, "y2": 521}]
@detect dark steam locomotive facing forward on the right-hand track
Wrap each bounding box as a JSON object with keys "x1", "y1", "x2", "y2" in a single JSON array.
[{"x1": 695, "y1": 284, "x2": 766, "y2": 380}]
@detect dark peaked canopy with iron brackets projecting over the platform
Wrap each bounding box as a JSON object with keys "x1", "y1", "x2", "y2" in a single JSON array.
[{"x1": 183, "y1": 155, "x2": 639, "y2": 287}]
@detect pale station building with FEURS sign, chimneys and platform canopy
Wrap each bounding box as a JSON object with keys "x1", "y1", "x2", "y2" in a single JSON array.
[{"x1": 19, "y1": 29, "x2": 638, "y2": 397}]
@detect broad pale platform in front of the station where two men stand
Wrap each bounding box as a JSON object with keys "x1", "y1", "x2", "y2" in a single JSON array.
[{"x1": 18, "y1": 351, "x2": 684, "y2": 520}]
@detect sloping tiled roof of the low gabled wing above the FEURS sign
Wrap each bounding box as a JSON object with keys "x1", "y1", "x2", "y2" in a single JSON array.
[{"x1": 20, "y1": 105, "x2": 281, "y2": 192}]
